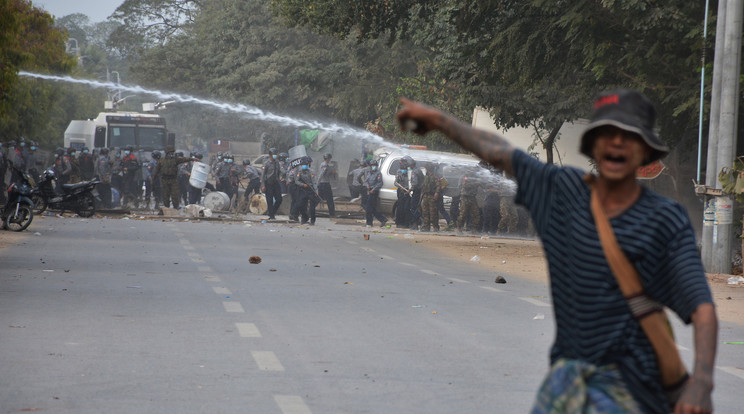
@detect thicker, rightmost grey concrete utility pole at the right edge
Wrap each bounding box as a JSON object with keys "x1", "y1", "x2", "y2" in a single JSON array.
[{"x1": 709, "y1": 0, "x2": 744, "y2": 273}]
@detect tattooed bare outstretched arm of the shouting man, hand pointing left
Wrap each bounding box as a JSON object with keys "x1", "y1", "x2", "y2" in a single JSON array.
[{"x1": 396, "y1": 98, "x2": 514, "y2": 175}]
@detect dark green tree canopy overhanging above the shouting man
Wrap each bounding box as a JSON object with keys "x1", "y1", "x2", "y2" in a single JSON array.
[{"x1": 272, "y1": 0, "x2": 715, "y2": 158}]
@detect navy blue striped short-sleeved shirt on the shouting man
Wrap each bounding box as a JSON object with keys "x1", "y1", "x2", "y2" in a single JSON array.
[{"x1": 512, "y1": 151, "x2": 713, "y2": 413}]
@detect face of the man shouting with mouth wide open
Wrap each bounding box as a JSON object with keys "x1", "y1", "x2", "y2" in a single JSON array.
[{"x1": 592, "y1": 125, "x2": 651, "y2": 181}]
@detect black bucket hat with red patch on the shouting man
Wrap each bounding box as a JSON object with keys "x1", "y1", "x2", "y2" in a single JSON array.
[{"x1": 580, "y1": 89, "x2": 669, "y2": 165}]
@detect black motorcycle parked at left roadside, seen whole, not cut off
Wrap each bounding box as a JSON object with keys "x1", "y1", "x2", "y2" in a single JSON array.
[{"x1": 31, "y1": 168, "x2": 101, "y2": 217}]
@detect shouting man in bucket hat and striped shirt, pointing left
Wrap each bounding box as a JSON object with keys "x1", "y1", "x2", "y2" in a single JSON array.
[{"x1": 397, "y1": 90, "x2": 718, "y2": 413}]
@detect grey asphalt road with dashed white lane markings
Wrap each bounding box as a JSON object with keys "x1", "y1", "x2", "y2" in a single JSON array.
[{"x1": 0, "y1": 217, "x2": 744, "y2": 414}]
